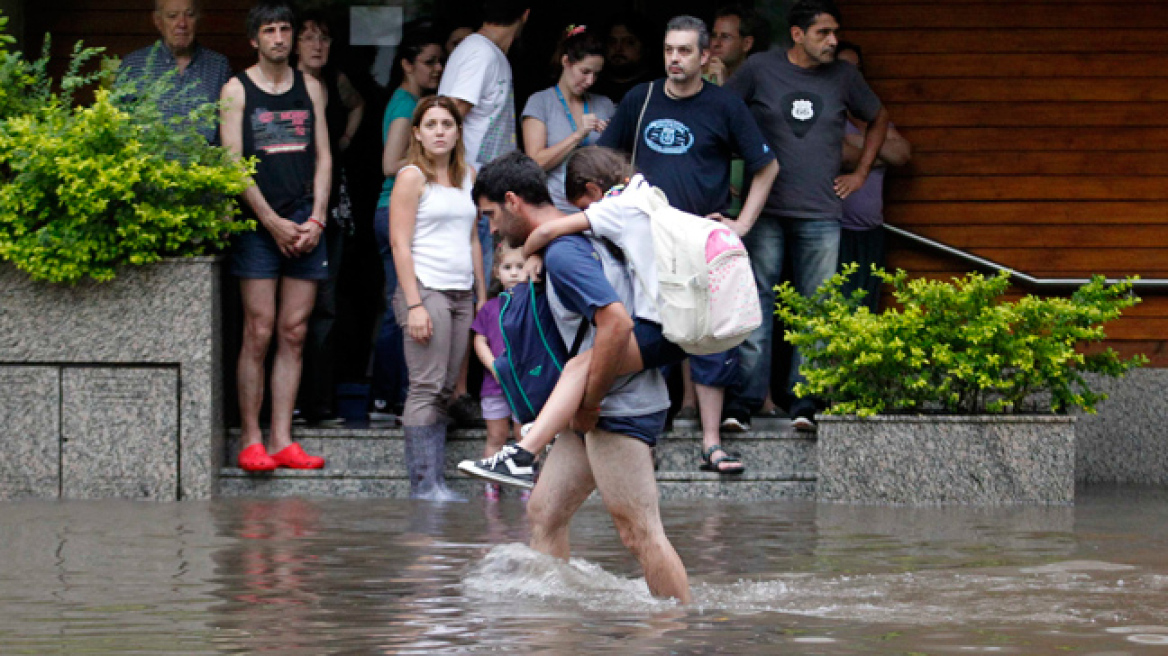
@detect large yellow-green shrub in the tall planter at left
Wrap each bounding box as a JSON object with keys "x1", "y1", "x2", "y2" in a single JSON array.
[{"x1": 0, "y1": 28, "x2": 255, "y2": 282}]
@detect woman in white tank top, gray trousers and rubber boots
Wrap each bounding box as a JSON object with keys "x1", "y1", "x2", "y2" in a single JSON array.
[{"x1": 389, "y1": 96, "x2": 486, "y2": 500}]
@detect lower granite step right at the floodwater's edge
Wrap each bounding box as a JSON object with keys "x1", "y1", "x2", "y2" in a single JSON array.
[{"x1": 220, "y1": 467, "x2": 815, "y2": 501}]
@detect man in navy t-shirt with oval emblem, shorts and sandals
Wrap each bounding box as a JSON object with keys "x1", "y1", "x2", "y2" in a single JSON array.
[{"x1": 598, "y1": 16, "x2": 779, "y2": 464}]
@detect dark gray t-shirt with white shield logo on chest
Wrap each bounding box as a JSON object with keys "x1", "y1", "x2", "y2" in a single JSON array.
[{"x1": 726, "y1": 49, "x2": 881, "y2": 221}]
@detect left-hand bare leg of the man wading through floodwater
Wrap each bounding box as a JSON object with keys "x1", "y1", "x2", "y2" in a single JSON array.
[{"x1": 527, "y1": 432, "x2": 602, "y2": 560}]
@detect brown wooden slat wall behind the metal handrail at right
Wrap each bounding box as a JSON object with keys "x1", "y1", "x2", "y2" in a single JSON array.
[{"x1": 841, "y1": 0, "x2": 1168, "y2": 367}]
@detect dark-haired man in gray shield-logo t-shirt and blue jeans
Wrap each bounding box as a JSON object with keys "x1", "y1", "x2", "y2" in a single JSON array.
[{"x1": 726, "y1": 0, "x2": 888, "y2": 430}]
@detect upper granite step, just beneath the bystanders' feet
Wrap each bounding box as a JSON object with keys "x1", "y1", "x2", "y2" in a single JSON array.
[{"x1": 227, "y1": 421, "x2": 815, "y2": 473}]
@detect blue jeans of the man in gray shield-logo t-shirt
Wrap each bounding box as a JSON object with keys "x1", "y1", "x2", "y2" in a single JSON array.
[{"x1": 726, "y1": 215, "x2": 840, "y2": 412}]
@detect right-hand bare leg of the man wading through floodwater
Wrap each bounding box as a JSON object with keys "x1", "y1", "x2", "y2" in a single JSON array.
[{"x1": 588, "y1": 428, "x2": 690, "y2": 603}]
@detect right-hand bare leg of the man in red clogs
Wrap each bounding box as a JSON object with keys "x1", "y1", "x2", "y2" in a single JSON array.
[{"x1": 267, "y1": 278, "x2": 317, "y2": 453}]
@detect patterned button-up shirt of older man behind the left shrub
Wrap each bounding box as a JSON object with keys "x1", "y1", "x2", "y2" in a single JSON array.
[{"x1": 118, "y1": 40, "x2": 231, "y2": 144}]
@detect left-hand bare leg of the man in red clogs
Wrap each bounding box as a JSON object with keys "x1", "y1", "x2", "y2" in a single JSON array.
[{"x1": 235, "y1": 279, "x2": 279, "y2": 448}]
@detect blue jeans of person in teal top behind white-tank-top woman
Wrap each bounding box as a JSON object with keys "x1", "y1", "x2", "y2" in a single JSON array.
[{"x1": 369, "y1": 208, "x2": 409, "y2": 407}]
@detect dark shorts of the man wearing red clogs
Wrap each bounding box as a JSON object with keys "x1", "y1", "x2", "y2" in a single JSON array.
[{"x1": 231, "y1": 201, "x2": 328, "y2": 280}]
